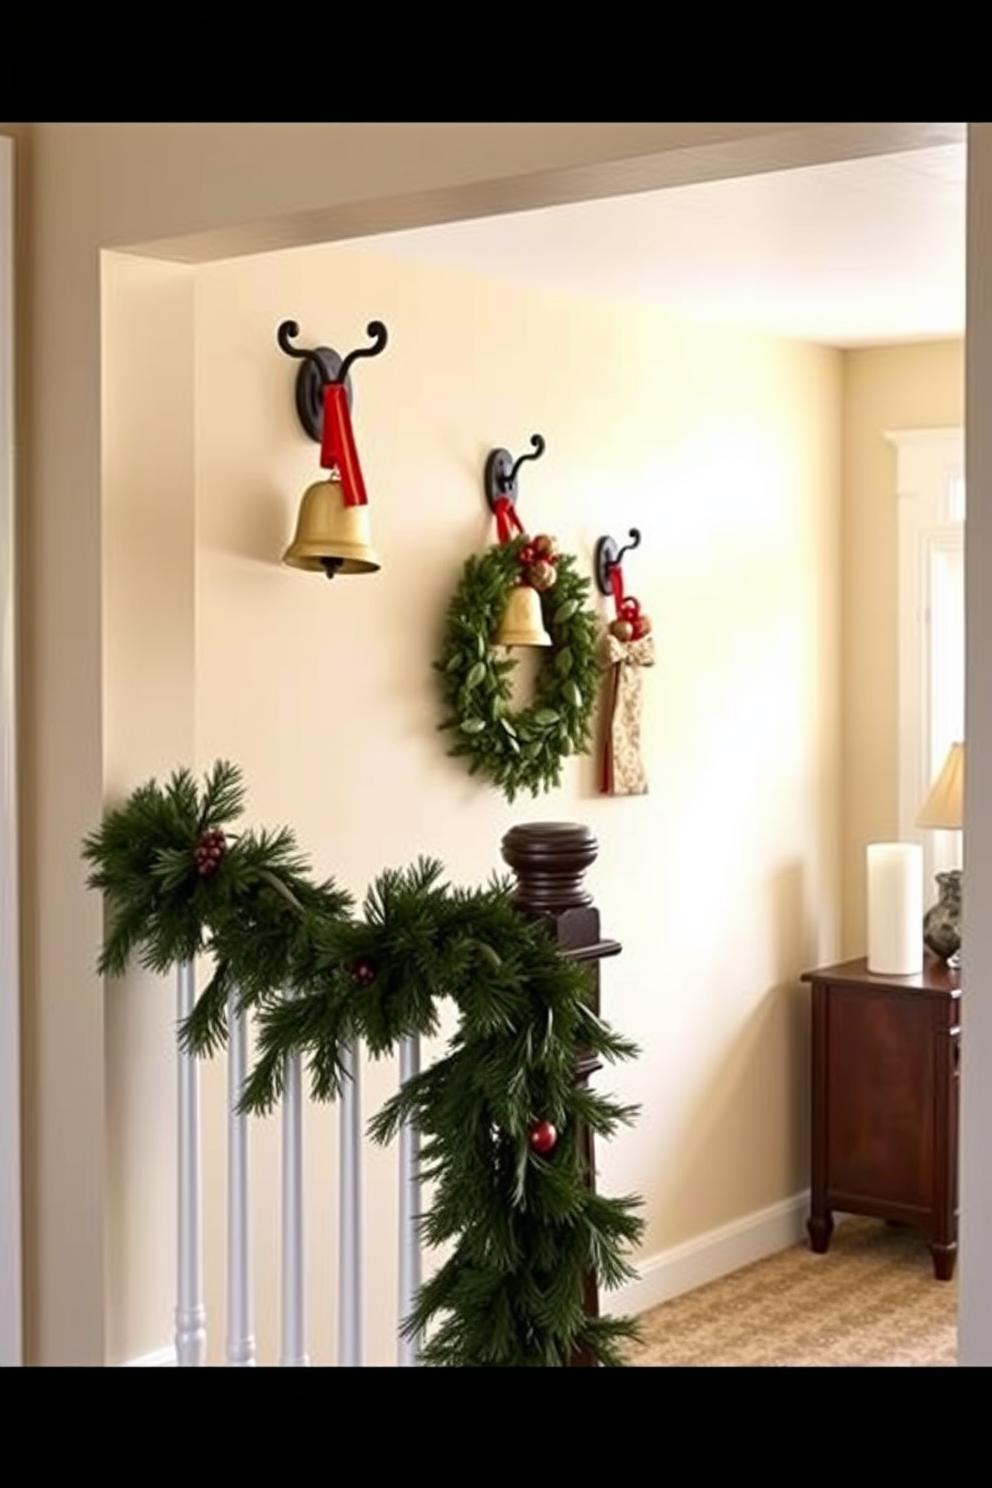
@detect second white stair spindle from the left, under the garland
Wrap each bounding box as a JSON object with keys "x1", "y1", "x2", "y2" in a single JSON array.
[{"x1": 228, "y1": 991, "x2": 254, "y2": 1367}]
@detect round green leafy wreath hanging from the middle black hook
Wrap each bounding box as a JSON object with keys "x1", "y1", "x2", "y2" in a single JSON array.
[{"x1": 434, "y1": 536, "x2": 601, "y2": 801}]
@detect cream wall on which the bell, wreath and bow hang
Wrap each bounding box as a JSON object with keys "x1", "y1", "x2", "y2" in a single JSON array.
[{"x1": 107, "y1": 238, "x2": 840, "y2": 1363}]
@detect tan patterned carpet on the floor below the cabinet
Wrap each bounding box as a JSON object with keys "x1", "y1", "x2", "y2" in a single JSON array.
[{"x1": 629, "y1": 1219, "x2": 958, "y2": 1366}]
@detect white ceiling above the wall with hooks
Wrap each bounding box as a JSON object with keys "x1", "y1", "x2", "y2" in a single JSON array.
[{"x1": 337, "y1": 143, "x2": 965, "y2": 347}]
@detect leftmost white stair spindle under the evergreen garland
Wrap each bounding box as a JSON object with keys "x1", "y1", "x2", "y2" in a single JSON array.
[{"x1": 175, "y1": 961, "x2": 207, "y2": 1366}]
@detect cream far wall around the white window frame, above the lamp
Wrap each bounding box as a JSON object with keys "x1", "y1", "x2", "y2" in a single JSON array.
[{"x1": 842, "y1": 341, "x2": 964, "y2": 955}]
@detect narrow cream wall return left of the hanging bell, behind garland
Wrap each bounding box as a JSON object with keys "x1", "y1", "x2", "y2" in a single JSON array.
[{"x1": 101, "y1": 253, "x2": 196, "y2": 1360}]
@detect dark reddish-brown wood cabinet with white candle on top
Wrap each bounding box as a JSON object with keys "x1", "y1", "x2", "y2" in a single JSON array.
[{"x1": 803, "y1": 955, "x2": 961, "y2": 1281}]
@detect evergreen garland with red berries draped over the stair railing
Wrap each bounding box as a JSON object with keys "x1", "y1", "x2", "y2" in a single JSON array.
[{"x1": 83, "y1": 762, "x2": 642, "y2": 1366}]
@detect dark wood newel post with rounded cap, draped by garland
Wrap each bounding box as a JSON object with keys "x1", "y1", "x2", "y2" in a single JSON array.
[{"x1": 503, "y1": 821, "x2": 622, "y2": 1366}]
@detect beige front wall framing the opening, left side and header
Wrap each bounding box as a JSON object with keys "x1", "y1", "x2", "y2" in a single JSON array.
[{"x1": 0, "y1": 124, "x2": 963, "y2": 1364}]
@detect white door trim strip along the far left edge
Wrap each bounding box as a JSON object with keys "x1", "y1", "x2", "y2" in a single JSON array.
[{"x1": 0, "y1": 138, "x2": 22, "y2": 1366}]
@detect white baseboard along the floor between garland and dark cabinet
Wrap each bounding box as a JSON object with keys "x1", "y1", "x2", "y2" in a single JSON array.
[{"x1": 601, "y1": 1192, "x2": 809, "y2": 1314}]
